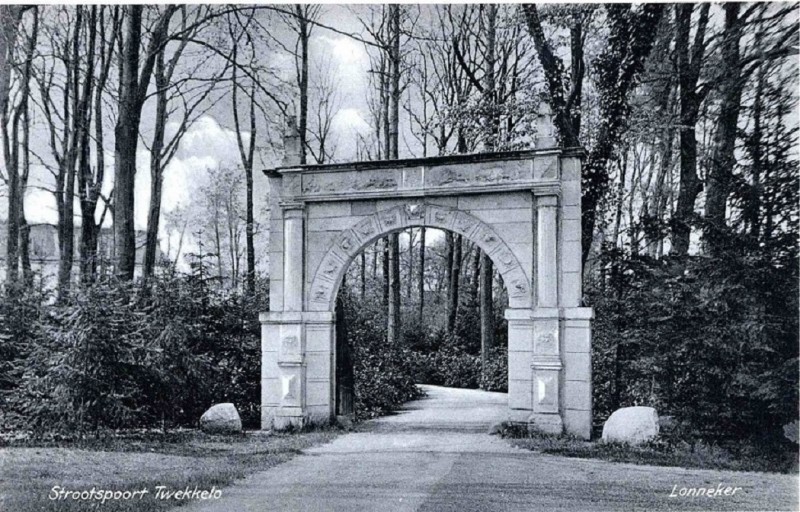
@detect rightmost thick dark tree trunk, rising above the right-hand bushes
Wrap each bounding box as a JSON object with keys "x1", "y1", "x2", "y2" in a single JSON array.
[{"x1": 704, "y1": 3, "x2": 742, "y2": 256}]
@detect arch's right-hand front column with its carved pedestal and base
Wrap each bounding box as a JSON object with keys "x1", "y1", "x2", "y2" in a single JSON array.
[{"x1": 529, "y1": 194, "x2": 563, "y2": 434}]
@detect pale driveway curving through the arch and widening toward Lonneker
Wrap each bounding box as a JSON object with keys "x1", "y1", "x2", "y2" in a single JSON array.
[{"x1": 183, "y1": 386, "x2": 798, "y2": 512}]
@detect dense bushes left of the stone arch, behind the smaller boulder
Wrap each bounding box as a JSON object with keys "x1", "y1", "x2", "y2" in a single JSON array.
[{"x1": 2, "y1": 264, "x2": 264, "y2": 433}]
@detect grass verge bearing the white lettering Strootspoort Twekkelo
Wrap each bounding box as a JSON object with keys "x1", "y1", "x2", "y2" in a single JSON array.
[{"x1": 0, "y1": 429, "x2": 337, "y2": 512}]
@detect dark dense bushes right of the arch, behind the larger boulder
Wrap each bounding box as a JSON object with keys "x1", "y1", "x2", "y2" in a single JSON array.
[{"x1": 589, "y1": 239, "x2": 798, "y2": 441}]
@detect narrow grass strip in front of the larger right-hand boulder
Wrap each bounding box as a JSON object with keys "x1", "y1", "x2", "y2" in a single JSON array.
[{"x1": 502, "y1": 426, "x2": 798, "y2": 473}]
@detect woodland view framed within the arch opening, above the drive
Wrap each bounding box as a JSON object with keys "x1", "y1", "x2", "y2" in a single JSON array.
[{"x1": 334, "y1": 224, "x2": 509, "y2": 423}]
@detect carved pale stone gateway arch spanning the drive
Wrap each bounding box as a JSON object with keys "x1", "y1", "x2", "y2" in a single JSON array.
[{"x1": 261, "y1": 126, "x2": 592, "y2": 438}]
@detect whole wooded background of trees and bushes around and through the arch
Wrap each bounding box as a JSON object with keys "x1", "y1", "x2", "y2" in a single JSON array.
[{"x1": 0, "y1": 3, "x2": 798, "y2": 454}]
